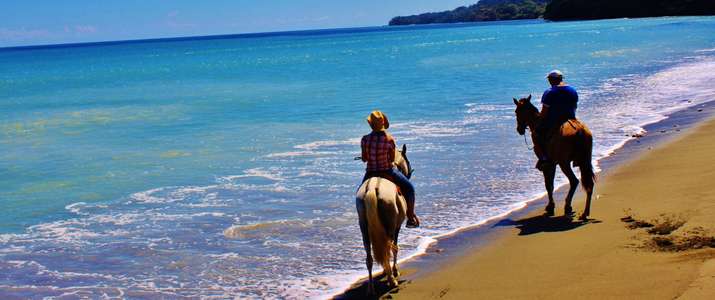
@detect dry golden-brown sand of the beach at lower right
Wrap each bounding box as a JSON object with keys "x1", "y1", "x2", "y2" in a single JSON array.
[{"x1": 387, "y1": 120, "x2": 715, "y2": 299}]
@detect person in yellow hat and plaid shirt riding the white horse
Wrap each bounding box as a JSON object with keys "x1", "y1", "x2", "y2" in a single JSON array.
[{"x1": 360, "y1": 111, "x2": 420, "y2": 228}]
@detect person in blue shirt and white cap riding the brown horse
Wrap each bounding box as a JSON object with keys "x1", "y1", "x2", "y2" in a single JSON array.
[{"x1": 534, "y1": 70, "x2": 578, "y2": 170}]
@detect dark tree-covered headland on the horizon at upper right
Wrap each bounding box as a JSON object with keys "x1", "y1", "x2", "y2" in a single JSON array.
[{"x1": 389, "y1": 0, "x2": 715, "y2": 26}]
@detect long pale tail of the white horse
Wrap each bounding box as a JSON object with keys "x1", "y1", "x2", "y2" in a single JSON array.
[{"x1": 363, "y1": 189, "x2": 395, "y2": 271}]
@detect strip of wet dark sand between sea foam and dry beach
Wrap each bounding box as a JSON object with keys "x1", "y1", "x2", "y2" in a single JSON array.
[{"x1": 336, "y1": 100, "x2": 715, "y2": 299}]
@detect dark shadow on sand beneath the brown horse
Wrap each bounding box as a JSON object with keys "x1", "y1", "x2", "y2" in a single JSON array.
[{"x1": 492, "y1": 215, "x2": 601, "y2": 235}]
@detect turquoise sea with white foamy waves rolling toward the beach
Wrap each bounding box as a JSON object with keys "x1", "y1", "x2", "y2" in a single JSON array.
[{"x1": 0, "y1": 17, "x2": 715, "y2": 298}]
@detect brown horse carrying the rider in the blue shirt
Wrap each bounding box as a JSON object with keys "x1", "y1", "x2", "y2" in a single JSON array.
[{"x1": 514, "y1": 95, "x2": 596, "y2": 220}]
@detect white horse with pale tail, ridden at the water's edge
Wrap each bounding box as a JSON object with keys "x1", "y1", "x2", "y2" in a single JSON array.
[{"x1": 355, "y1": 145, "x2": 413, "y2": 294}]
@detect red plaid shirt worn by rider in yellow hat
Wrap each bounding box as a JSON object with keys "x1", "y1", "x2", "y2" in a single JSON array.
[{"x1": 360, "y1": 131, "x2": 395, "y2": 172}]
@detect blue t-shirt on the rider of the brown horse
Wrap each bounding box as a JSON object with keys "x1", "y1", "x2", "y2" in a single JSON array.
[{"x1": 541, "y1": 85, "x2": 578, "y2": 125}]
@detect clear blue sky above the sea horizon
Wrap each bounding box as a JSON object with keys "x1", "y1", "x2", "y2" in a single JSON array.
[{"x1": 0, "y1": 0, "x2": 478, "y2": 47}]
